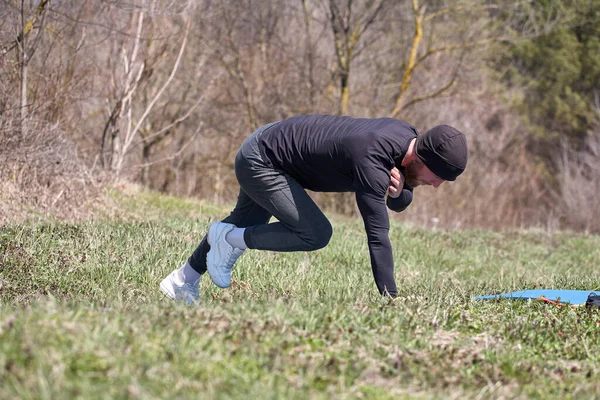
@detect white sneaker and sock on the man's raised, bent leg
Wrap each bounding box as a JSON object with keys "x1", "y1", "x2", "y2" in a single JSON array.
[{"x1": 206, "y1": 222, "x2": 244, "y2": 289}]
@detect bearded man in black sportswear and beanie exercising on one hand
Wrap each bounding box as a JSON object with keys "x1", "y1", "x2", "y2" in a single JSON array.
[{"x1": 160, "y1": 115, "x2": 467, "y2": 303}]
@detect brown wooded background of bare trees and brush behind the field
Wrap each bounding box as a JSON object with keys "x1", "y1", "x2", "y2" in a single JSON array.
[{"x1": 0, "y1": 0, "x2": 600, "y2": 232}]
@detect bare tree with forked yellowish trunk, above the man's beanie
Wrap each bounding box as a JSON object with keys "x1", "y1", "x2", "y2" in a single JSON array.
[{"x1": 389, "y1": 0, "x2": 562, "y2": 117}]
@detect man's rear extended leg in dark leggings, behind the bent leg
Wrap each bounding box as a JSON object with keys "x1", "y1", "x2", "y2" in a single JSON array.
[{"x1": 188, "y1": 188, "x2": 271, "y2": 274}]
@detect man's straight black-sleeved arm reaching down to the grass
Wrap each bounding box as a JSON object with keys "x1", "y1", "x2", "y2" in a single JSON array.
[{"x1": 356, "y1": 191, "x2": 398, "y2": 297}]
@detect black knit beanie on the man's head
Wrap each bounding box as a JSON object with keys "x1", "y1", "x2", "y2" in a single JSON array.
[{"x1": 415, "y1": 125, "x2": 467, "y2": 181}]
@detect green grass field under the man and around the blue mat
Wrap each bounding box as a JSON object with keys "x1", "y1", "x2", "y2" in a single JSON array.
[{"x1": 0, "y1": 193, "x2": 600, "y2": 399}]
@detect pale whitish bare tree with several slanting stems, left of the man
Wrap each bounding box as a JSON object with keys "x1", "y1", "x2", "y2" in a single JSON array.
[{"x1": 100, "y1": 2, "x2": 202, "y2": 179}]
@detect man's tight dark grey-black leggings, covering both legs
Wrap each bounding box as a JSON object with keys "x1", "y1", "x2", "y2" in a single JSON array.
[{"x1": 188, "y1": 123, "x2": 332, "y2": 273}]
